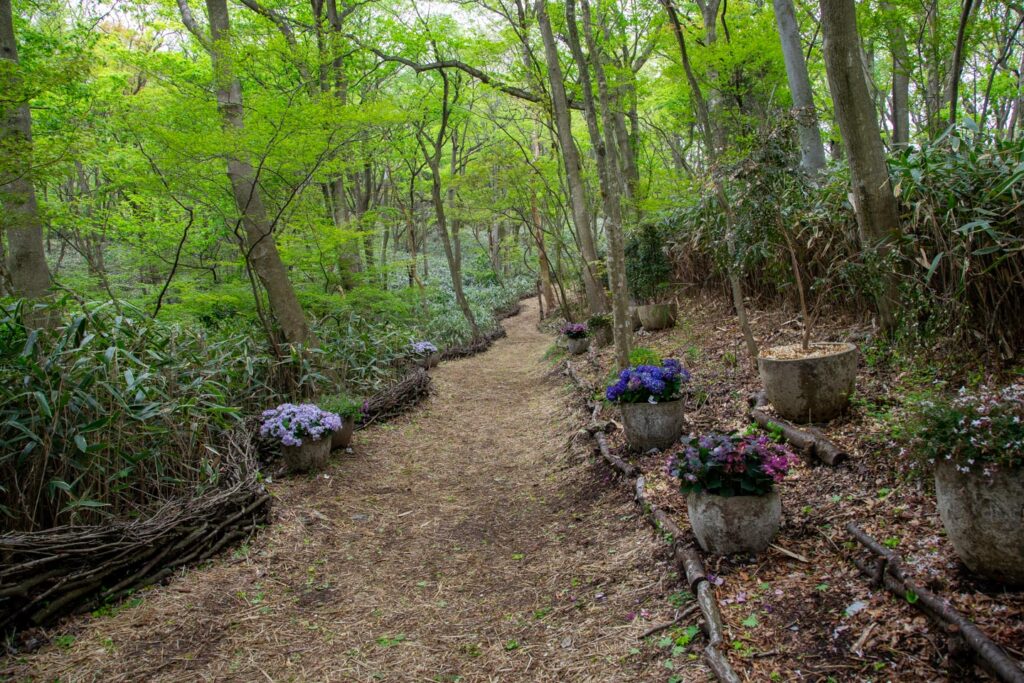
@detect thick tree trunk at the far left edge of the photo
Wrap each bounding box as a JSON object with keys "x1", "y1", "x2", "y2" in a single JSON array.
[{"x1": 0, "y1": 0, "x2": 50, "y2": 299}]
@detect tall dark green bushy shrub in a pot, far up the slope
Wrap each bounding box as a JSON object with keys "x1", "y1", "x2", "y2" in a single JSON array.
[{"x1": 626, "y1": 223, "x2": 677, "y2": 331}]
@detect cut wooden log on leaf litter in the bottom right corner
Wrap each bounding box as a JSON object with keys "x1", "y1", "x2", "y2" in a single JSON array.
[{"x1": 846, "y1": 522, "x2": 1024, "y2": 683}]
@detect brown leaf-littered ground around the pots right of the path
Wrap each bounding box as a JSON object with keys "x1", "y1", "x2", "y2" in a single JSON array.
[{"x1": 570, "y1": 298, "x2": 1024, "y2": 681}]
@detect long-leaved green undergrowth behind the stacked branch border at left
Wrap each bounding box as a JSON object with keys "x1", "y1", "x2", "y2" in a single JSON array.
[{"x1": 0, "y1": 302, "x2": 292, "y2": 529}]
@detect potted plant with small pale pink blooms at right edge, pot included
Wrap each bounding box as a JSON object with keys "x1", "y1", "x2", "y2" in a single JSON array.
[{"x1": 910, "y1": 384, "x2": 1024, "y2": 586}]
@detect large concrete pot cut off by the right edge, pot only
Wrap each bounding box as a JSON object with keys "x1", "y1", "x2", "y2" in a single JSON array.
[{"x1": 935, "y1": 461, "x2": 1024, "y2": 586}]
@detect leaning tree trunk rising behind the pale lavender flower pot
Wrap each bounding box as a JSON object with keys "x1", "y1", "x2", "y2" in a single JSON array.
[{"x1": 197, "y1": 0, "x2": 316, "y2": 346}]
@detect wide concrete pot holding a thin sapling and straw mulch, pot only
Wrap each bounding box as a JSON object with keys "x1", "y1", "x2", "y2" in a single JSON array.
[{"x1": 758, "y1": 343, "x2": 857, "y2": 422}]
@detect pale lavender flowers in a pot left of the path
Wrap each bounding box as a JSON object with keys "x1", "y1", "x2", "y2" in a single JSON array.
[{"x1": 260, "y1": 403, "x2": 341, "y2": 472}]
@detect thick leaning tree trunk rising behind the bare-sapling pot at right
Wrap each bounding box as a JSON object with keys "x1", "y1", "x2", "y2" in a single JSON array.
[{"x1": 819, "y1": 0, "x2": 900, "y2": 333}]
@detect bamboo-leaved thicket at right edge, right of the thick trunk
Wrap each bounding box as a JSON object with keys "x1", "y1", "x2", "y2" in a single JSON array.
[{"x1": 892, "y1": 123, "x2": 1024, "y2": 349}]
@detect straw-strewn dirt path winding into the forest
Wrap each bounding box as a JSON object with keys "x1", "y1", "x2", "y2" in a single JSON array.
[{"x1": 8, "y1": 302, "x2": 688, "y2": 682}]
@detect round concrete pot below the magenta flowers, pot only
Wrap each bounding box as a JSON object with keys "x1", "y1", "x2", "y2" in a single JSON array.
[{"x1": 686, "y1": 489, "x2": 782, "y2": 555}]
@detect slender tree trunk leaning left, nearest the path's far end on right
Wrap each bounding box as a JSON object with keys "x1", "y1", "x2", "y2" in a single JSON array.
[{"x1": 537, "y1": 0, "x2": 608, "y2": 314}]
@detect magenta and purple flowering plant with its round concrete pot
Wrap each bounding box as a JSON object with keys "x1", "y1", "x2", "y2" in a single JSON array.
[{"x1": 669, "y1": 433, "x2": 796, "y2": 555}]
